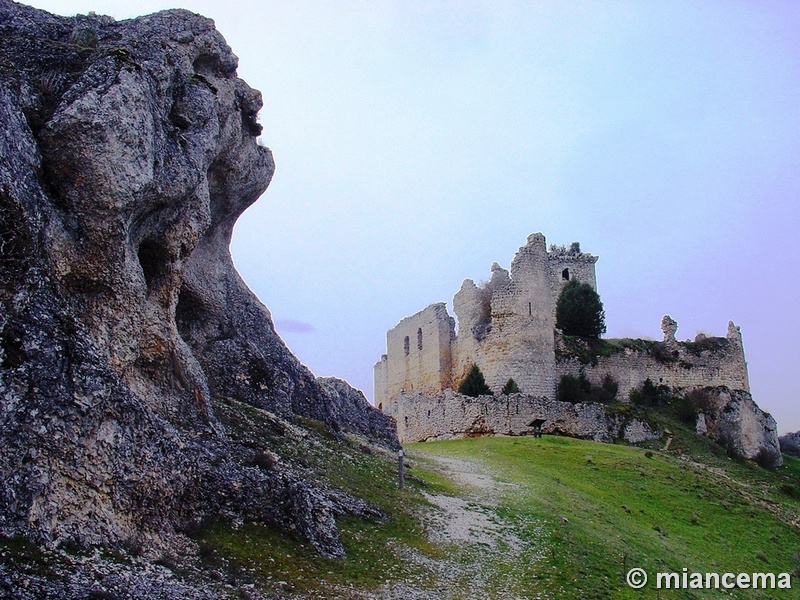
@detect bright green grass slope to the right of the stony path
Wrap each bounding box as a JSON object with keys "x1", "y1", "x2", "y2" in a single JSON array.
[{"x1": 409, "y1": 436, "x2": 800, "y2": 598}]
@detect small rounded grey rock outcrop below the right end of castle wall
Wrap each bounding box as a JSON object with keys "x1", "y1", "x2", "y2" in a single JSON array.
[{"x1": 696, "y1": 387, "x2": 783, "y2": 467}]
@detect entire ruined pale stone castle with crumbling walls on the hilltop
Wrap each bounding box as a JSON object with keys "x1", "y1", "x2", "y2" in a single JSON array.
[{"x1": 375, "y1": 233, "x2": 750, "y2": 448}]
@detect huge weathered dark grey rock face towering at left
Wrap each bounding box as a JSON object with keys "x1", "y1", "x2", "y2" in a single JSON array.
[{"x1": 0, "y1": 0, "x2": 397, "y2": 556}]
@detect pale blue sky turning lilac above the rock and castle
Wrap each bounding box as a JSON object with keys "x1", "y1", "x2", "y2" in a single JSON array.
[{"x1": 29, "y1": 0, "x2": 800, "y2": 433}]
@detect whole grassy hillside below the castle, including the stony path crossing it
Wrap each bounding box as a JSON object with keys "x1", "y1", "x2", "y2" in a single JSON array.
[{"x1": 188, "y1": 400, "x2": 800, "y2": 598}]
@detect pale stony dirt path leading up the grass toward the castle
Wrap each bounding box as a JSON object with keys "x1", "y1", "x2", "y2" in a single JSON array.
[{"x1": 376, "y1": 455, "x2": 543, "y2": 600}]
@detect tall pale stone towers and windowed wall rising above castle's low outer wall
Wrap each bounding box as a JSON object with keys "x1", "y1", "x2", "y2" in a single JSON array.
[{"x1": 375, "y1": 233, "x2": 597, "y2": 410}]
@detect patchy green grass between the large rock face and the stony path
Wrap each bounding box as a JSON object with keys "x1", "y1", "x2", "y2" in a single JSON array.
[{"x1": 189, "y1": 404, "x2": 450, "y2": 598}]
